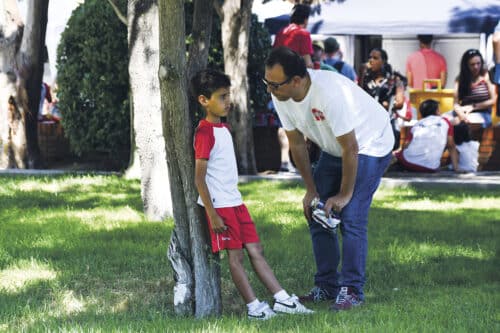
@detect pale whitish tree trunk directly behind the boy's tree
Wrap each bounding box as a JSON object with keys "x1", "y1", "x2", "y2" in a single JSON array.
[{"x1": 127, "y1": 0, "x2": 172, "y2": 221}]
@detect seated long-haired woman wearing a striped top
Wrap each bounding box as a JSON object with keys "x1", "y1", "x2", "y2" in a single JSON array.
[{"x1": 446, "y1": 49, "x2": 497, "y2": 128}]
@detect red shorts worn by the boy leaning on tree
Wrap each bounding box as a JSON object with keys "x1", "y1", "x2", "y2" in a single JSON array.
[{"x1": 205, "y1": 204, "x2": 260, "y2": 253}]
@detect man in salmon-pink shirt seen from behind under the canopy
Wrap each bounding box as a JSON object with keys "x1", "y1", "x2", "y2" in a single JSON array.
[{"x1": 406, "y1": 35, "x2": 448, "y2": 89}]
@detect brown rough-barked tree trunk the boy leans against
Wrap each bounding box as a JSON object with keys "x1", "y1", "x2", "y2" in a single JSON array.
[{"x1": 159, "y1": 0, "x2": 221, "y2": 317}]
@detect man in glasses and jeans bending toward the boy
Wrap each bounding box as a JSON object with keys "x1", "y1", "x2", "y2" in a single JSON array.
[{"x1": 264, "y1": 48, "x2": 394, "y2": 310}]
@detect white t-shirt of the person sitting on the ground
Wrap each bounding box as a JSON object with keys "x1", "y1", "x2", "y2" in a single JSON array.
[{"x1": 403, "y1": 116, "x2": 453, "y2": 170}]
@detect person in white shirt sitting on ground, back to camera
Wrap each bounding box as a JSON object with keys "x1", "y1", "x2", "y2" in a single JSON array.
[{"x1": 394, "y1": 99, "x2": 459, "y2": 172}]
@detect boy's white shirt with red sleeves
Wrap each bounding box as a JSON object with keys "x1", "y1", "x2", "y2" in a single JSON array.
[{"x1": 194, "y1": 119, "x2": 243, "y2": 208}]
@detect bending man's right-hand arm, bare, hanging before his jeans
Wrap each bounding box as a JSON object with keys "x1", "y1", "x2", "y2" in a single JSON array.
[{"x1": 325, "y1": 130, "x2": 358, "y2": 212}]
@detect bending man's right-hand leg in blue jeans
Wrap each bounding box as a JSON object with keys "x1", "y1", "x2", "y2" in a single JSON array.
[{"x1": 340, "y1": 154, "x2": 391, "y2": 301}]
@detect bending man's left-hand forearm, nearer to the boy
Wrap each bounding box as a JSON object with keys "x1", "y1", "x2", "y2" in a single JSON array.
[{"x1": 286, "y1": 130, "x2": 318, "y2": 220}]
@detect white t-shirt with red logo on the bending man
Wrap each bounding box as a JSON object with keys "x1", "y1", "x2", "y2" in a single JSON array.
[{"x1": 272, "y1": 70, "x2": 394, "y2": 157}]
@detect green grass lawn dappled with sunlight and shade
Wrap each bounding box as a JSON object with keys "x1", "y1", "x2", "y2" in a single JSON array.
[{"x1": 0, "y1": 176, "x2": 500, "y2": 332}]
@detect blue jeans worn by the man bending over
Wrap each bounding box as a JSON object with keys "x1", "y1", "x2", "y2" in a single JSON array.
[{"x1": 309, "y1": 152, "x2": 392, "y2": 300}]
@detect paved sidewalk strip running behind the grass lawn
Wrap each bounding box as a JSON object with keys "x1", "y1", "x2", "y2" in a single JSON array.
[{"x1": 240, "y1": 171, "x2": 500, "y2": 189}]
